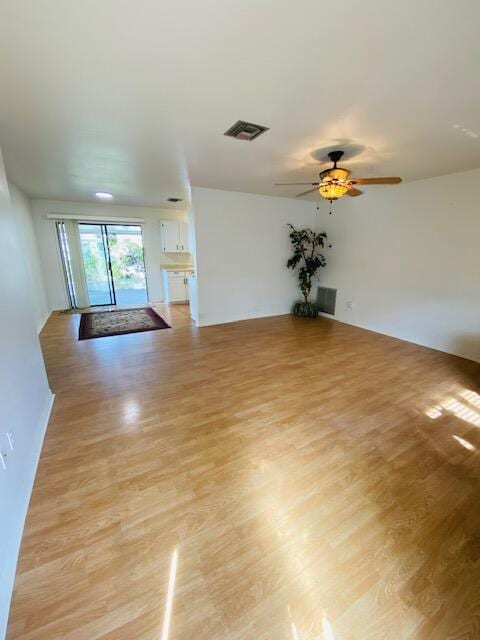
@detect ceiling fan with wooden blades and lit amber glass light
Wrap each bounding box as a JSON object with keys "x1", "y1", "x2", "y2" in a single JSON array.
[{"x1": 275, "y1": 151, "x2": 402, "y2": 202}]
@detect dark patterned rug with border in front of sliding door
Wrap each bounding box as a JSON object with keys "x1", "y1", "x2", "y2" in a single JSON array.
[{"x1": 78, "y1": 307, "x2": 170, "y2": 340}]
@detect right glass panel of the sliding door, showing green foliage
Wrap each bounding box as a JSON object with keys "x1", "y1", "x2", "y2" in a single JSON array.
[{"x1": 106, "y1": 224, "x2": 148, "y2": 304}]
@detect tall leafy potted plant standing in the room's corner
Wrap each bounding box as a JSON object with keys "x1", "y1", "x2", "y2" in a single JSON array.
[{"x1": 287, "y1": 224, "x2": 327, "y2": 318}]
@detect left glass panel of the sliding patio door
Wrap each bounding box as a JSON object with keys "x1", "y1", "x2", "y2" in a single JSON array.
[{"x1": 78, "y1": 223, "x2": 116, "y2": 307}]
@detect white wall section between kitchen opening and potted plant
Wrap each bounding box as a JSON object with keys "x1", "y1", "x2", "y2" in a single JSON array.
[{"x1": 192, "y1": 187, "x2": 315, "y2": 326}]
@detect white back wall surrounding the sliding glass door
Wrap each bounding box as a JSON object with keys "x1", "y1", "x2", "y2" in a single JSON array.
[{"x1": 32, "y1": 200, "x2": 191, "y2": 310}]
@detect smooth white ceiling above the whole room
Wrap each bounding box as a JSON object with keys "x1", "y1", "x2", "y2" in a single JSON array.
[{"x1": 0, "y1": 0, "x2": 480, "y2": 206}]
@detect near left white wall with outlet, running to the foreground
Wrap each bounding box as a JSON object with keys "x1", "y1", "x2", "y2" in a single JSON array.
[{"x1": 0, "y1": 154, "x2": 53, "y2": 638}]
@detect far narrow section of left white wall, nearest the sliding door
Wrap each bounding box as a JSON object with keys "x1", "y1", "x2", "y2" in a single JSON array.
[{"x1": 9, "y1": 182, "x2": 50, "y2": 333}]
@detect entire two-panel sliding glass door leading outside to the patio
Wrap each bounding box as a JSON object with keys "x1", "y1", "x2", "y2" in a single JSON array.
[{"x1": 78, "y1": 223, "x2": 148, "y2": 307}]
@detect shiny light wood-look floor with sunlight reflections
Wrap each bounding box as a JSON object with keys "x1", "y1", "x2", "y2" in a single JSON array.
[{"x1": 8, "y1": 307, "x2": 480, "y2": 640}]
